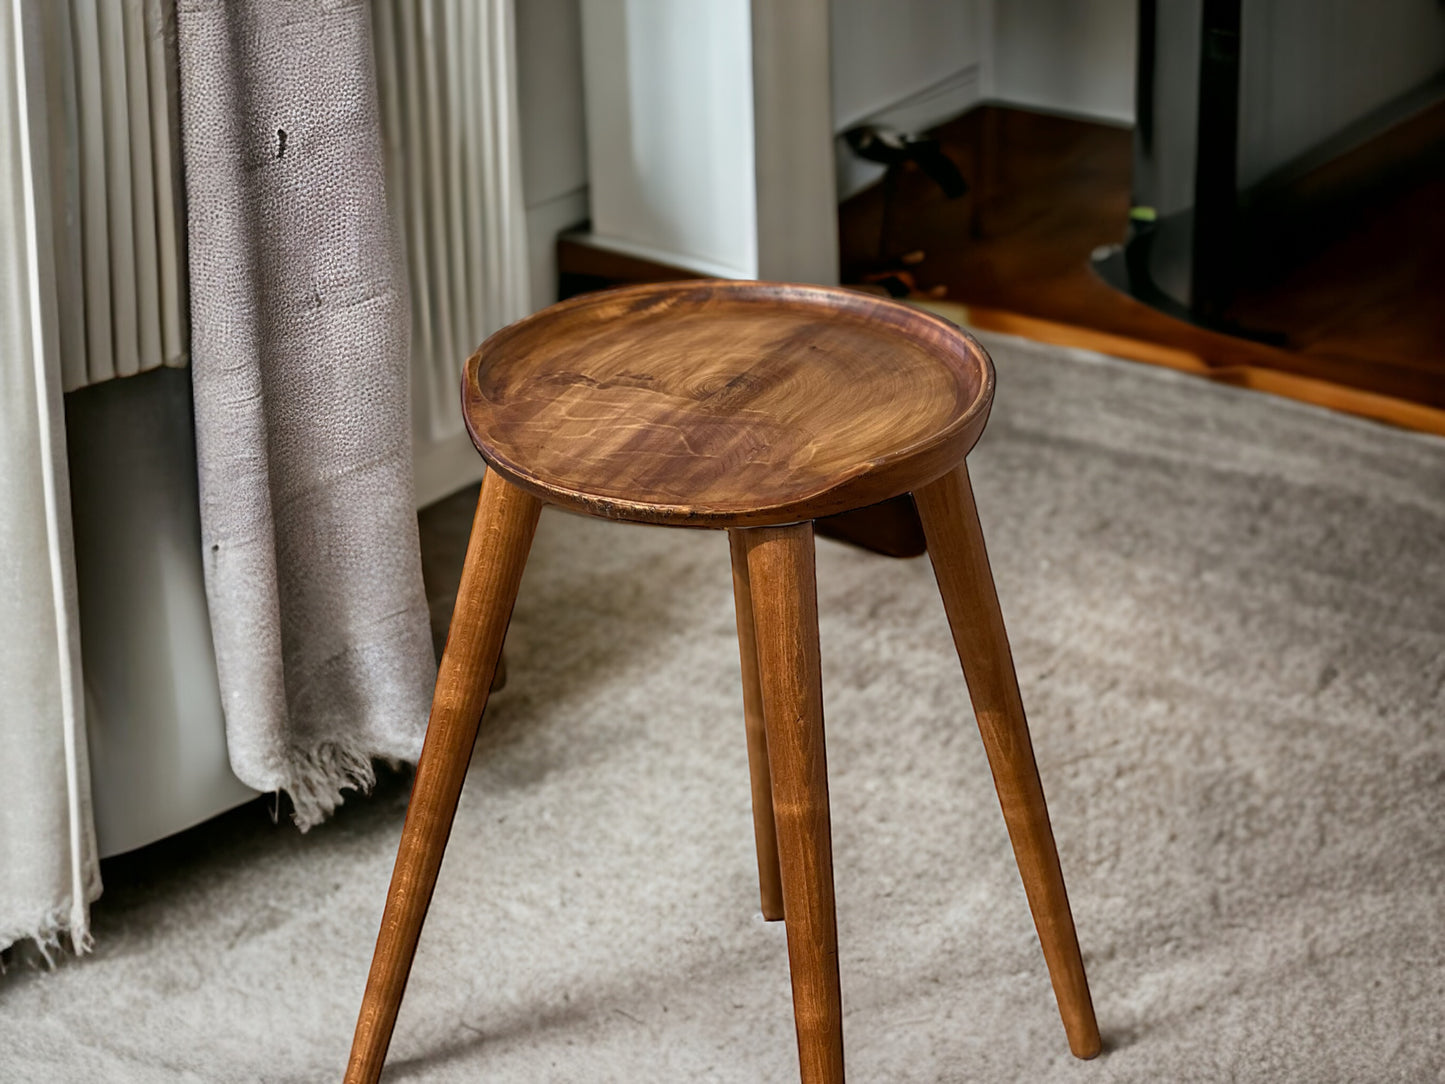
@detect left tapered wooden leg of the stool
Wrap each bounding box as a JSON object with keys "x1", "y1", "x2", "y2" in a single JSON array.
[{"x1": 345, "y1": 471, "x2": 542, "y2": 1084}]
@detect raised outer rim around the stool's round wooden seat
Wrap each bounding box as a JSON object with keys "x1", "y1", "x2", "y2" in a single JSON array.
[{"x1": 461, "y1": 279, "x2": 994, "y2": 528}]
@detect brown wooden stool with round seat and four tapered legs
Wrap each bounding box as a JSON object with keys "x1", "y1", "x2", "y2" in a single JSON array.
[{"x1": 347, "y1": 280, "x2": 1100, "y2": 1084}]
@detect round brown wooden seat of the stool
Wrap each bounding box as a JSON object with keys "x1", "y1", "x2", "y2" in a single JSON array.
[{"x1": 462, "y1": 280, "x2": 993, "y2": 528}]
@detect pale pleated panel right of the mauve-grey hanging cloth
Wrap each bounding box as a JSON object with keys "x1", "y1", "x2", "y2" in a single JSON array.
[{"x1": 371, "y1": 0, "x2": 530, "y2": 445}]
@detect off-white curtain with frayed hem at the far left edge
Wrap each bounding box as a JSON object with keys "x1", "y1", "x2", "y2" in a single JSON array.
[{"x1": 0, "y1": 0, "x2": 100, "y2": 951}]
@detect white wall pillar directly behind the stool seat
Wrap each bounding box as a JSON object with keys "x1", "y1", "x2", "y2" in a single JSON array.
[{"x1": 569, "y1": 0, "x2": 838, "y2": 282}]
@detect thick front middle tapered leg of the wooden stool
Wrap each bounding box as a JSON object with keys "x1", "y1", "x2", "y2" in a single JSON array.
[{"x1": 740, "y1": 523, "x2": 842, "y2": 1084}]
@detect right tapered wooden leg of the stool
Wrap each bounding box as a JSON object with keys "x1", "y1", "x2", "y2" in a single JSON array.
[{"x1": 913, "y1": 464, "x2": 1100, "y2": 1058}]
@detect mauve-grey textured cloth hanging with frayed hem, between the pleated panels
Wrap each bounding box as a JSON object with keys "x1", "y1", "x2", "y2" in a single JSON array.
[{"x1": 176, "y1": 0, "x2": 435, "y2": 828}]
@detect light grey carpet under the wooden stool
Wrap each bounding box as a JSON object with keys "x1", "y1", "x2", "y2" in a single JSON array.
[{"x1": 0, "y1": 338, "x2": 1445, "y2": 1084}]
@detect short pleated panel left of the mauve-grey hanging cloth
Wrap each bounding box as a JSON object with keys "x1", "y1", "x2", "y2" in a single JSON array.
[{"x1": 41, "y1": 0, "x2": 189, "y2": 392}]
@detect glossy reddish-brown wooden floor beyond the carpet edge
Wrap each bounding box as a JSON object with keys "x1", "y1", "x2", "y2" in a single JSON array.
[{"x1": 840, "y1": 107, "x2": 1445, "y2": 434}]
